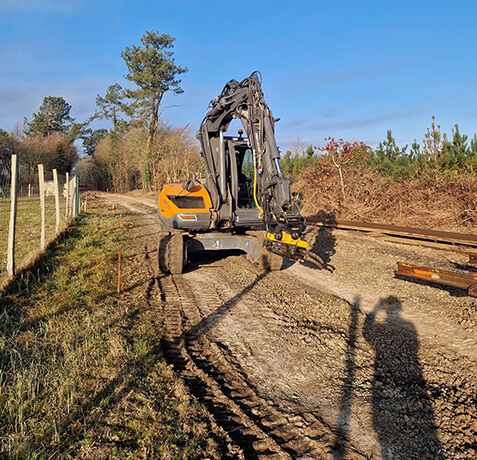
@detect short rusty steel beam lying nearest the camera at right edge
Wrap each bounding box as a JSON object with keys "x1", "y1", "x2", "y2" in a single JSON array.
[{"x1": 394, "y1": 262, "x2": 477, "y2": 297}]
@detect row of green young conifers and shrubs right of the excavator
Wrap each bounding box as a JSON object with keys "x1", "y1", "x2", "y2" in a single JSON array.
[{"x1": 282, "y1": 117, "x2": 477, "y2": 180}]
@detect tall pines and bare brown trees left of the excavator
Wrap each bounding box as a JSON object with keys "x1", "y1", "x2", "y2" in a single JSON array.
[{"x1": 0, "y1": 31, "x2": 195, "y2": 192}]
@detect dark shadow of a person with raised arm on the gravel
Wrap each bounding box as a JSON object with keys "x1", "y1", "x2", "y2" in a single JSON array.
[{"x1": 363, "y1": 296, "x2": 445, "y2": 459}]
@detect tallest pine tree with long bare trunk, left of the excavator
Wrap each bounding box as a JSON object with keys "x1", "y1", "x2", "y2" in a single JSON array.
[{"x1": 121, "y1": 31, "x2": 187, "y2": 187}]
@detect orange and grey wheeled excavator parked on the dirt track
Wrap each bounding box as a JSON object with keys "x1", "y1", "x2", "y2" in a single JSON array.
[{"x1": 158, "y1": 72, "x2": 319, "y2": 274}]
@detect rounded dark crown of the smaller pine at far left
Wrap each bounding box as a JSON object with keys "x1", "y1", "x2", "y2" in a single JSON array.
[{"x1": 25, "y1": 96, "x2": 74, "y2": 137}]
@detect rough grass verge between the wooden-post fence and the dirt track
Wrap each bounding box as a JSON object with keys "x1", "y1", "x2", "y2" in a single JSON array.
[{"x1": 0, "y1": 210, "x2": 220, "y2": 459}]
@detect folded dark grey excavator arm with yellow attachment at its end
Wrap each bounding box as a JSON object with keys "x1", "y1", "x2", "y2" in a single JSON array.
[{"x1": 197, "y1": 72, "x2": 307, "y2": 259}]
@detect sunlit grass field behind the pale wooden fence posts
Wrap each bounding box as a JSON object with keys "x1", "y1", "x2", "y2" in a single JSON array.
[{"x1": 0, "y1": 197, "x2": 66, "y2": 278}]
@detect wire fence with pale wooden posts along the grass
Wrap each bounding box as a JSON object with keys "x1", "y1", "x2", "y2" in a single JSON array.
[{"x1": 0, "y1": 156, "x2": 79, "y2": 282}]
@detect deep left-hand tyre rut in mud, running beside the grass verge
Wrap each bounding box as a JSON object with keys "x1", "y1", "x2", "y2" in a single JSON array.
[{"x1": 158, "y1": 276, "x2": 288, "y2": 458}]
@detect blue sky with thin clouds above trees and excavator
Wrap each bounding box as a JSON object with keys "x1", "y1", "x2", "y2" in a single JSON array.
[{"x1": 0, "y1": 0, "x2": 477, "y2": 150}]
